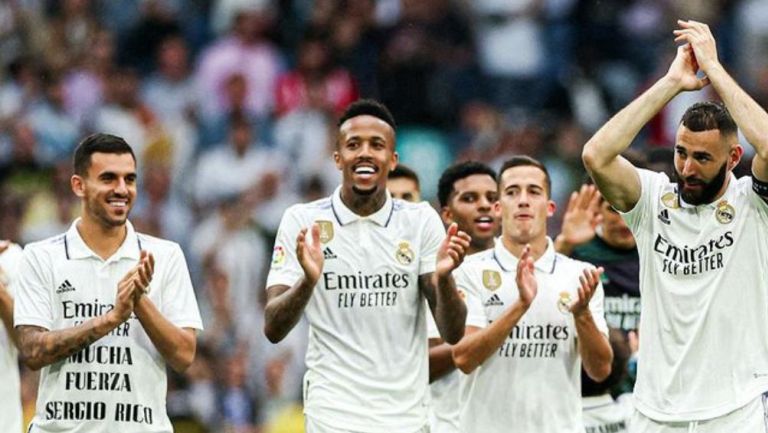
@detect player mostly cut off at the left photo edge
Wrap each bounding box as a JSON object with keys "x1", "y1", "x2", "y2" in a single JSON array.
[{"x1": 0, "y1": 241, "x2": 22, "y2": 433}]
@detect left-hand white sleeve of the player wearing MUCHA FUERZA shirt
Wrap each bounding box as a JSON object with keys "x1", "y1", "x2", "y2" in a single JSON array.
[{"x1": 13, "y1": 248, "x2": 54, "y2": 330}]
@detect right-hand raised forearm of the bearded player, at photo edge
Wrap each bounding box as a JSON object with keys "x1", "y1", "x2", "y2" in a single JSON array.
[{"x1": 707, "y1": 63, "x2": 768, "y2": 161}]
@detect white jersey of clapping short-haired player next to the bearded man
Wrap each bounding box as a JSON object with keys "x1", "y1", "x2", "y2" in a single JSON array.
[{"x1": 454, "y1": 239, "x2": 608, "y2": 433}]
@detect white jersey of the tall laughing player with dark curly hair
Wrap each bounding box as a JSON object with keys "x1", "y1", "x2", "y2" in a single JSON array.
[{"x1": 267, "y1": 188, "x2": 445, "y2": 433}]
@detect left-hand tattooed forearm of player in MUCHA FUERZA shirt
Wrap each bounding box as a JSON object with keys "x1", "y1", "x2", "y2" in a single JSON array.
[{"x1": 17, "y1": 313, "x2": 120, "y2": 370}]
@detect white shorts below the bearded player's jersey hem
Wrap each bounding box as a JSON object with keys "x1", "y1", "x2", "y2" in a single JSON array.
[{"x1": 629, "y1": 392, "x2": 768, "y2": 433}]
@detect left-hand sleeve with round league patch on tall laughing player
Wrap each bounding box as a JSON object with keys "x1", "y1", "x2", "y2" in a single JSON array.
[{"x1": 266, "y1": 207, "x2": 304, "y2": 289}]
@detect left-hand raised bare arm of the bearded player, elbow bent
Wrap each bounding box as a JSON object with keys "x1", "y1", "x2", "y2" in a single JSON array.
[{"x1": 582, "y1": 41, "x2": 708, "y2": 212}]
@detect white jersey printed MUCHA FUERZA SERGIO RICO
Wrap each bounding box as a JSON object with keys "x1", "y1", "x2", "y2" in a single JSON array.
[{"x1": 14, "y1": 221, "x2": 202, "y2": 433}]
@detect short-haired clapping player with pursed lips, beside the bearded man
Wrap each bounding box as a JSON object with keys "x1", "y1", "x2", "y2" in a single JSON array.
[{"x1": 453, "y1": 156, "x2": 612, "y2": 433}]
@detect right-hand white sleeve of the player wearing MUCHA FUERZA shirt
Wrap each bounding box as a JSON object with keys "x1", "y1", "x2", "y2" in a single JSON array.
[{"x1": 160, "y1": 245, "x2": 203, "y2": 330}]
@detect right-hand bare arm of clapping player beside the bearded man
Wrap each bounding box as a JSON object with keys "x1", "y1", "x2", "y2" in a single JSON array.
[{"x1": 571, "y1": 268, "x2": 613, "y2": 382}]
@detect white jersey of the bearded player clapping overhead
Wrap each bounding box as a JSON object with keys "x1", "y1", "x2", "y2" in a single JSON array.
[{"x1": 623, "y1": 170, "x2": 768, "y2": 421}]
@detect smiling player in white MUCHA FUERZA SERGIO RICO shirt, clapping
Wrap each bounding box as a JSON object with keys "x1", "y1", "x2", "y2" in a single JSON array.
[{"x1": 14, "y1": 134, "x2": 202, "y2": 433}]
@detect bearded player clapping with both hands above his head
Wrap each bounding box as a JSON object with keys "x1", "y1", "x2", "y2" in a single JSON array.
[{"x1": 583, "y1": 21, "x2": 768, "y2": 432}]
